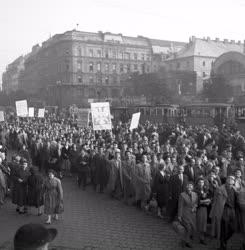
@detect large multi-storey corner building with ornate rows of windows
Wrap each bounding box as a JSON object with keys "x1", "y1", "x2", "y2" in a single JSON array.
[{"x1": 2, "y1": 30, "x2": 185, "y2": 106}]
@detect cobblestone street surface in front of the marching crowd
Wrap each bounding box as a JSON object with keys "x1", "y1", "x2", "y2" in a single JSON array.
[{"x1": 0, "y1": 178, "x2": 242, "y2": 250}]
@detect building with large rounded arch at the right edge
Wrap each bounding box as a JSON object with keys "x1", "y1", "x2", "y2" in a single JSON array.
[{"x1": 211, "y1": 52, "x2": 245, "y2": 97}]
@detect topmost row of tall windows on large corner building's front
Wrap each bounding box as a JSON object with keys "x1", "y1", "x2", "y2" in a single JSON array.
[{"x1": 77, "y1": 48, "x2": 151, "y2": 61}]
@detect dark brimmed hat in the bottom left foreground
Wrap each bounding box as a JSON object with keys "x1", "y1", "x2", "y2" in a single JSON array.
[{"x1": 14, "y1": 223, "x2": 57, "y2": 250}]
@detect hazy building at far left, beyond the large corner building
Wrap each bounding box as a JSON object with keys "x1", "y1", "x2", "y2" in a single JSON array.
[{"x1": 2, "y1": 56, "x2": 25, "y2": 93}]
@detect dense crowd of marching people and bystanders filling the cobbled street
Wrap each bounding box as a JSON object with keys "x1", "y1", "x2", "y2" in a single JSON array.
[{"x1": 0, "y1": 112, "x2": 245, "y2": 250}]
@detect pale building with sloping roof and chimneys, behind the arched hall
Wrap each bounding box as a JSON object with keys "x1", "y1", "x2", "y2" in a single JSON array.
[{"x1": 165, "y1": 36, "x2": 243, "y2": 93}]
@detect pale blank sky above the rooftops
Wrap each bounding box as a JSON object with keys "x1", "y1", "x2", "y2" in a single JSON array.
[{"x1": 0, "y1": 0, "x2": 245, "y2": 86}]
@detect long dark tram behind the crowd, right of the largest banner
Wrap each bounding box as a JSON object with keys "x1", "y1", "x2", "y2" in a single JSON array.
[{"x1": 111, "y1": 103, "x2": 235, "y2": 125}]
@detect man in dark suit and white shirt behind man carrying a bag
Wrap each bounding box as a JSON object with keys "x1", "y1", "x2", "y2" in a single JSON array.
[{"x1": 167, "y1": 165, "x2": 188, "y2": 222}]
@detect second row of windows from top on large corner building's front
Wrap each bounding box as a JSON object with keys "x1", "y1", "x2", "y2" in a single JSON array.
[{"x1": 75, "y1": 62, "x2": 150, "y2": 73}]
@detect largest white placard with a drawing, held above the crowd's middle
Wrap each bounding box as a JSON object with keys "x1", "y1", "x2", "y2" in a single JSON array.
[{"x1": 91, "y1": 102, "x2": 112, "y2": 130}]
